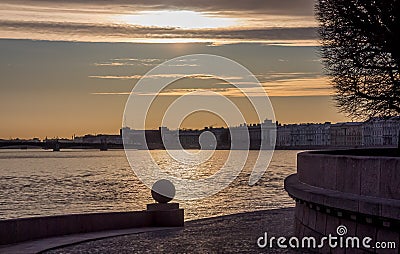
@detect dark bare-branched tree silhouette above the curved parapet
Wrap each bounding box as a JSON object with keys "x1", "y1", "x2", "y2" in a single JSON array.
[{"x1": 316, "y1": 0, "x2": 400, "y2": 119}]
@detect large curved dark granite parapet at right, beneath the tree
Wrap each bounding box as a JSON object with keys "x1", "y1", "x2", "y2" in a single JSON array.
[{"x1": 285, "y1": 149, "x2": 400, "y2": 253}]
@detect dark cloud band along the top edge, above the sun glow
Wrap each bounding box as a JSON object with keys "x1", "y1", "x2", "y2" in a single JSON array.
[{"x1": 2, "y1": 0, "x2": 314, "y2": 16}]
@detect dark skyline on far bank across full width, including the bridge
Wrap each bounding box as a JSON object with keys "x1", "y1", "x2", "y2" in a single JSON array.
[{"x1": 0, "y1": 116, "x2": 400, "y2": 151}]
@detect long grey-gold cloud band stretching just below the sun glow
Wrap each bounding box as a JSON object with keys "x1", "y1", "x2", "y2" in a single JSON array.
[{"x1": 0, "y1": 20, "x2": 317, "y2": 42}]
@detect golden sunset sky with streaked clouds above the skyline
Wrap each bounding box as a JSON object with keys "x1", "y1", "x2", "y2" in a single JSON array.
[{"x1": 0, "y1": 0, "x2": 349, "y2": 139}]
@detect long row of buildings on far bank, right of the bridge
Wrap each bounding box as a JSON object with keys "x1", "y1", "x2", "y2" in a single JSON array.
[{"x1": 119, "y1": 117, "x2": 400, "y2": 149}]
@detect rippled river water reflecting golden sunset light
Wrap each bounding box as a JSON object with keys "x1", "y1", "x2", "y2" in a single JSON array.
[{"x1": 0, "y1": 150, "x2": 298, "y2": 219}]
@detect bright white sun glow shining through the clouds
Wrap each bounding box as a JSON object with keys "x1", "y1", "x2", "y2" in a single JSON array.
[{"x1": 116, "y1": 11, "x2": 239, "y2": 29}]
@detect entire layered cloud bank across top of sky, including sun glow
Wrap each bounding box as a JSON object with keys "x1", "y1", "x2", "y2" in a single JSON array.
[{"x1": 0, "y1": 0, "x2": 317, "y2": 43}]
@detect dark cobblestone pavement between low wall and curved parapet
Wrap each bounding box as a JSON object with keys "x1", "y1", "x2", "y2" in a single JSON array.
[{"x1": 45, "y1": 208, "x2": 304, "y2": 254}]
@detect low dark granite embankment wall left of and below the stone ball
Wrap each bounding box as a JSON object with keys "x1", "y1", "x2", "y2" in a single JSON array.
[{"x1": 0, "y1": 204, "x2": 184, "y2": 245}]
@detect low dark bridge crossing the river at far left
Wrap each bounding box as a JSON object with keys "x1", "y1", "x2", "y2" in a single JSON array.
[{"x1": 0, "y1": 140, "x2": 124, "y2": 152}]
